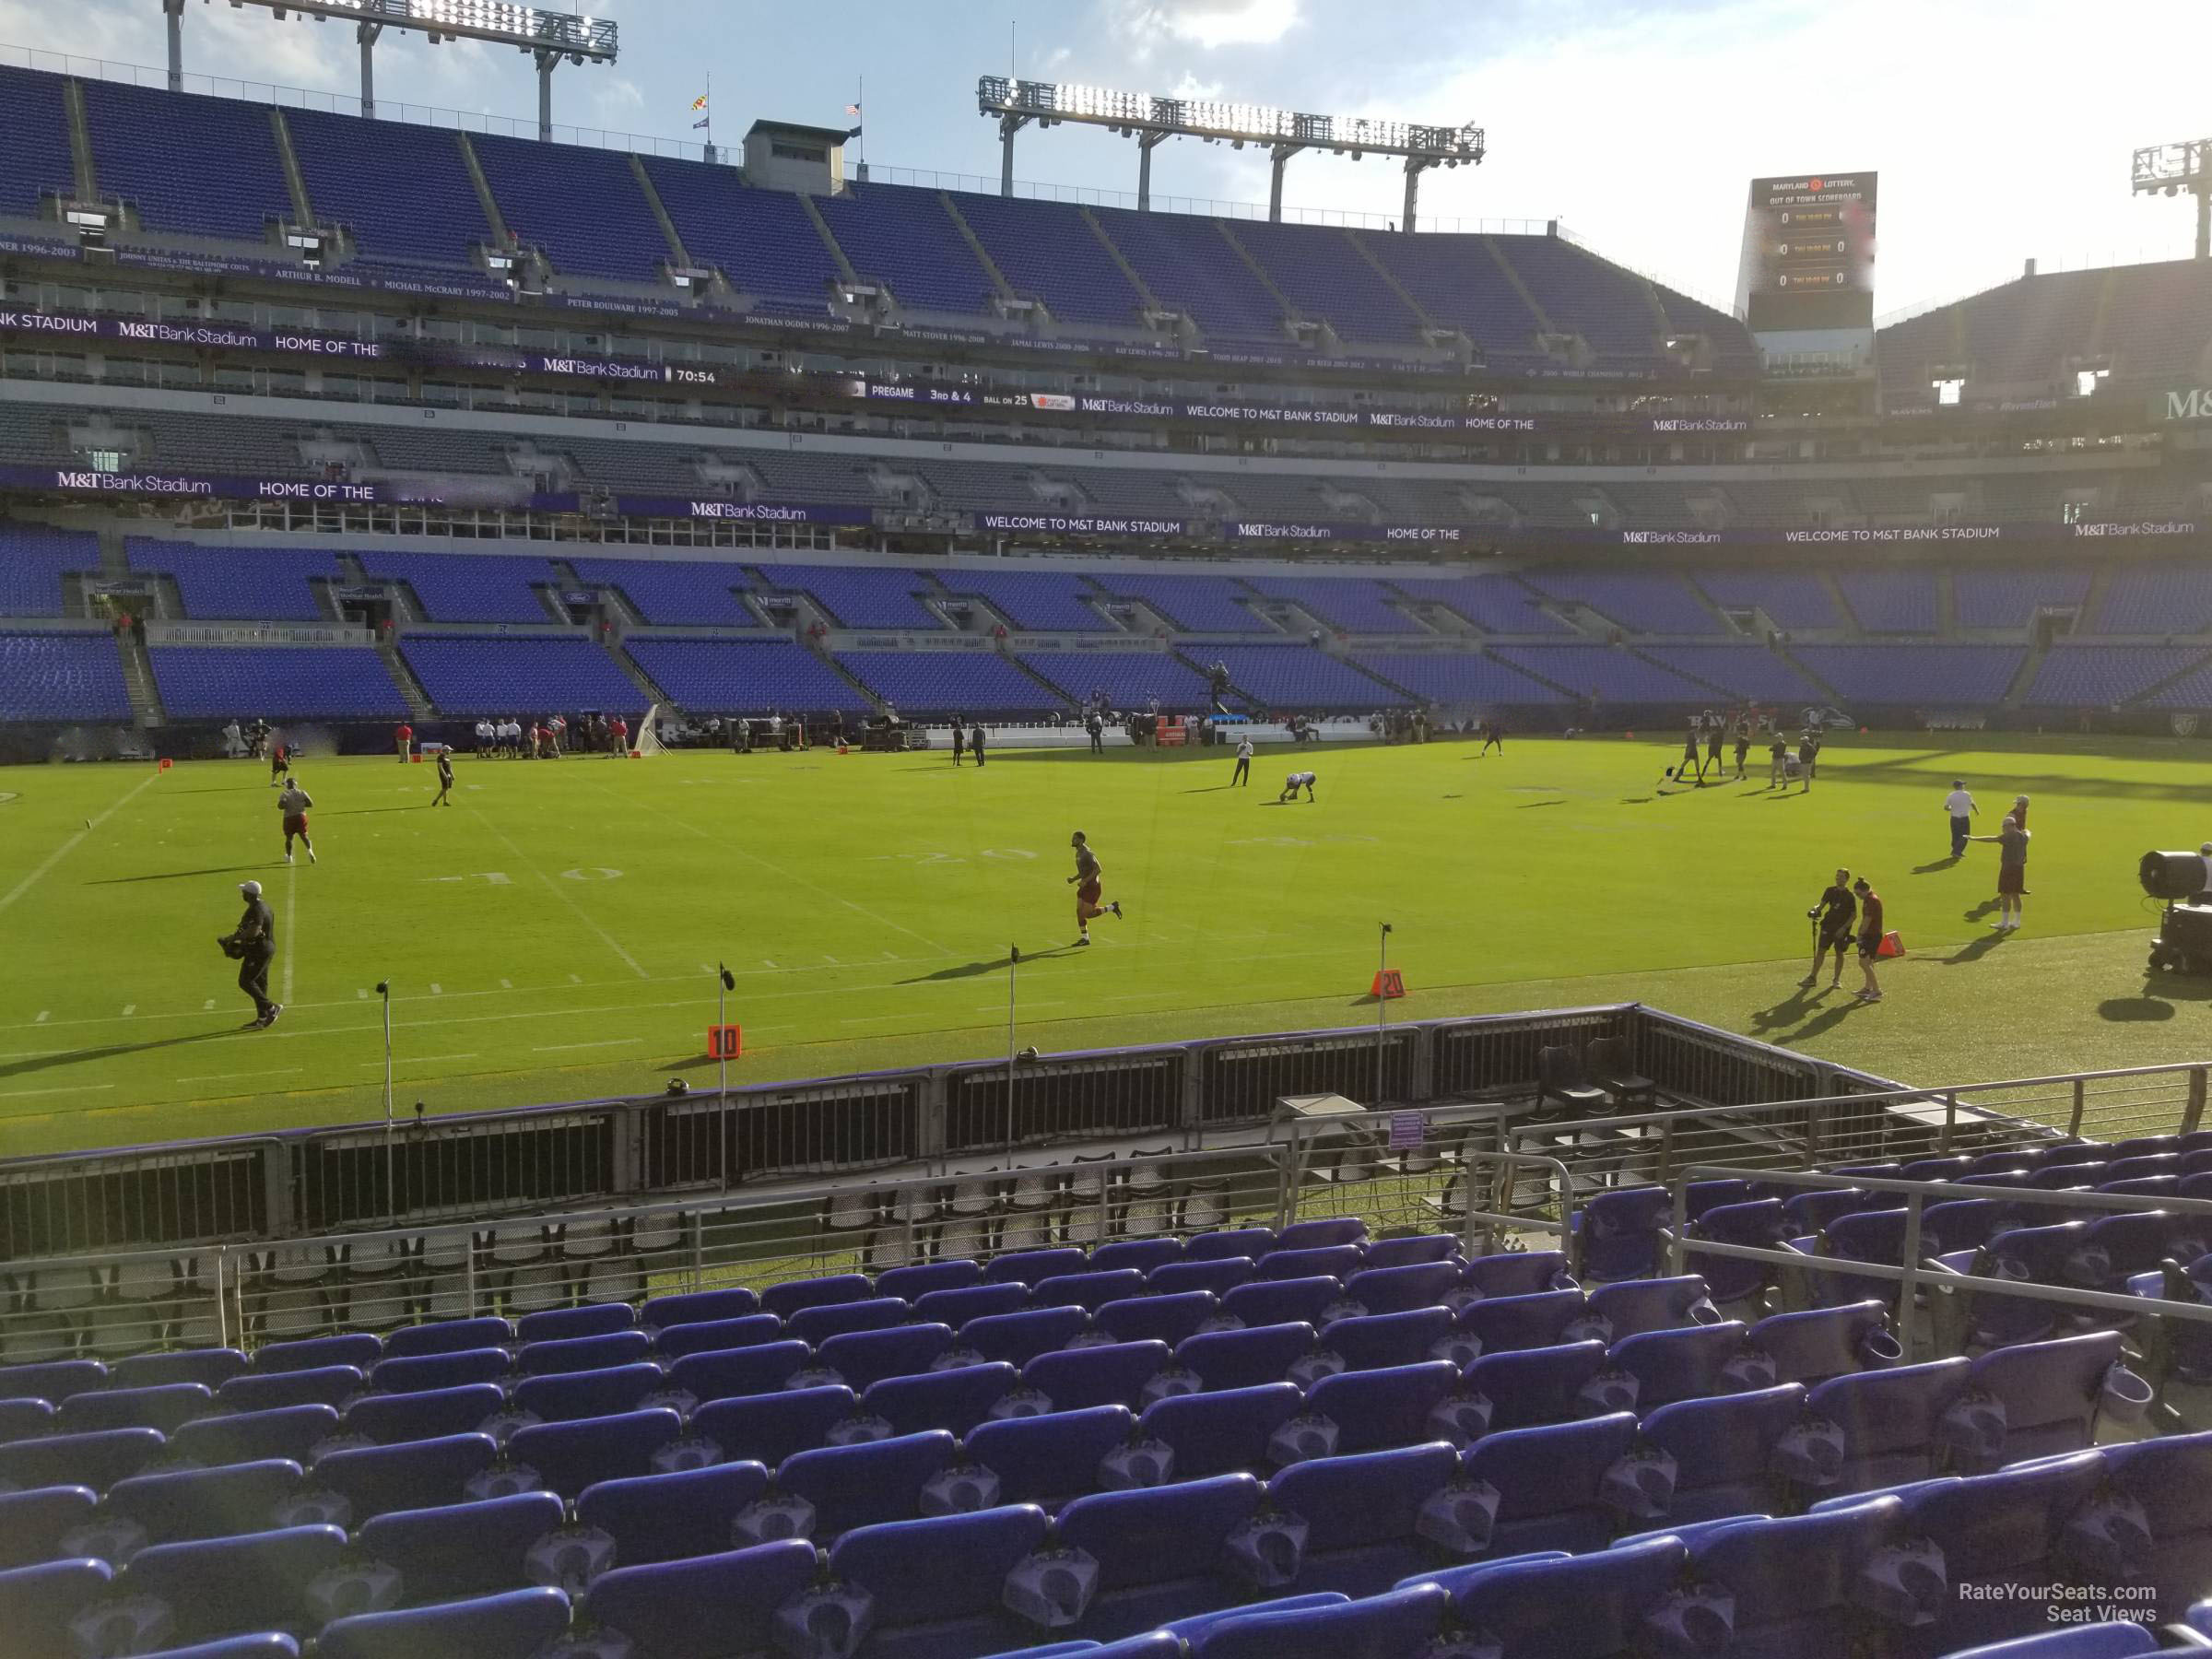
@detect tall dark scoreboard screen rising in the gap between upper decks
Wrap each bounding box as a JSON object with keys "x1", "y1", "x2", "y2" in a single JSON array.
[{"x1": 1736, "y1": 172, "x2": 1876, "y2": 334}]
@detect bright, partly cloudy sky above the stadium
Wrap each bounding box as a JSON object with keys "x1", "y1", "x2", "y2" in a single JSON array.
[{"x1": 17, "y1": 0, "x2": 2212, "y2": 314}]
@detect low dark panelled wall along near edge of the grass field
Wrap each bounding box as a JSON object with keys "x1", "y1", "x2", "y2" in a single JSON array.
[{"x1": 0, "y1": 1005, "x2": 1920, "y2": 1261}]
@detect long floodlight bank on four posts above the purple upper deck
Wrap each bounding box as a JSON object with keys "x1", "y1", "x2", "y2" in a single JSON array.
[{"x1": 975, "y1": 76, "x2": 1484, "y2": 230}]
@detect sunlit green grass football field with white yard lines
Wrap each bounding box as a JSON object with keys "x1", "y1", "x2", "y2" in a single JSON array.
[{"x1": 0, "y1": 735, "x2": 2212, "y2": 1152}]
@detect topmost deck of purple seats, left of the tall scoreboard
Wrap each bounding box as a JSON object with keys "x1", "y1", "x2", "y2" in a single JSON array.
[{"x1": 0, "y1": 71, "x2": 1752, "y2": 371}]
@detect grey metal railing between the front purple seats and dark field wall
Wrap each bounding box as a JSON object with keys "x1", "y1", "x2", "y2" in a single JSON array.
[{"x1": 0, "y1": 1108, "x2": 1575, "y2": 1362}]
